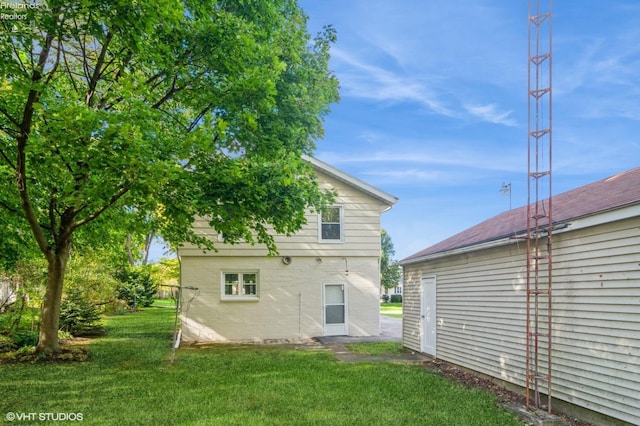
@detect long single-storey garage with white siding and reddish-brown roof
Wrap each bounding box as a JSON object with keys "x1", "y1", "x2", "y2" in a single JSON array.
[{"x1": 401, "y1": 168, "x2": 640, "y2": 424}]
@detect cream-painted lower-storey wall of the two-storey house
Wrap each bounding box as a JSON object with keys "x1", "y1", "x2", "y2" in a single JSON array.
[{"x1": 182, "y1": 257, "x2": 380, "y2": 341}]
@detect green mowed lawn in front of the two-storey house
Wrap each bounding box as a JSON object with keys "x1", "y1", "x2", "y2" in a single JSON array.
[{"x1": 0, "y1": 307, "x2": 521, "y2": 426}]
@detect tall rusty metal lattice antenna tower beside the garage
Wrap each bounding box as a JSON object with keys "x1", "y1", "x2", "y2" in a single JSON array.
[{"x1": 526, "y1": 0, "x2": 553, "y2": 413}]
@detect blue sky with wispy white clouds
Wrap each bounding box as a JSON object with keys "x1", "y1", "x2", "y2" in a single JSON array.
[{"x1": 299, "y1": 0, "x2": 640, "y2": 259}]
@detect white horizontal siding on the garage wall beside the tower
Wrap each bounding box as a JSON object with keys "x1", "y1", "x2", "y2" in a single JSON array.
[{"x1": 404, "y1": 218, "x2": 640, "y2": 424}]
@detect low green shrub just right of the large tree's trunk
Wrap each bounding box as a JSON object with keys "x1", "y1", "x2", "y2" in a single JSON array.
[{"x1": 60, "y1": 288, "x2": 103, "y2": 336}]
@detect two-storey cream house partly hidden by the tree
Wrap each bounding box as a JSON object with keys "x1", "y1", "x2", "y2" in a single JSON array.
[{"x1": 179, "y1": 158, "x2": 397, "y2": 341}]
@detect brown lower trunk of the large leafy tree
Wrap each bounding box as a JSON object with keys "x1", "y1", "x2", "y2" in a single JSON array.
[{"x1": 36, "y1": 242, "x2": 71, "y2": 354}]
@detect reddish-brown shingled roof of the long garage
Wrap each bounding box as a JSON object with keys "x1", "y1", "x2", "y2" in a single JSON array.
[{"x1": 401, "y1": 167, "x2": 640, "y2": 264}]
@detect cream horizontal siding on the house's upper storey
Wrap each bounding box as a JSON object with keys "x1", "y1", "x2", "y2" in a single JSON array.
[{"x1": 180, "y1": 169, "x2": 388, "y2": 257}]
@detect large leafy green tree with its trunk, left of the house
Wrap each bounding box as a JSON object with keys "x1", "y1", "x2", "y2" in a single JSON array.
[{"x1": 0, "y1": 0, "x2": 338, "y2": 353}]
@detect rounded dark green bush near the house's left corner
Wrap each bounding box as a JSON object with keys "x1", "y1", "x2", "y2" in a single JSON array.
[{"x1": 115, "y1": 267, "x2": 158, "y2": 310}]
